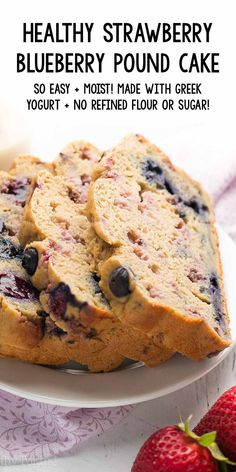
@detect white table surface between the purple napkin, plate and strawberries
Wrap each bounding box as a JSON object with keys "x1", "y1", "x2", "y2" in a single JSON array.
[{"x1": 6, "y1": 348, "x2": 236, "y2": 472}]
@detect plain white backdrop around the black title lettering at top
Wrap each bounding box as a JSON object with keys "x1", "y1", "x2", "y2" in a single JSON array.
[{"x1": 0, "y1": 0, "x2": 236, "y2": 157}]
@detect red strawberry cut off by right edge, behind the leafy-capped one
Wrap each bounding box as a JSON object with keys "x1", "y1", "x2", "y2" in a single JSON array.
[{"x1": 194, "y1": 386, "x2": 236, "y2": 461}]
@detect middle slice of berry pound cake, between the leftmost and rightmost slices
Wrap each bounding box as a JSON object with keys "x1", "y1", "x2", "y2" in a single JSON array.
[{"x1": 20, "y1": 142, "x2": 172, "y2": 366}]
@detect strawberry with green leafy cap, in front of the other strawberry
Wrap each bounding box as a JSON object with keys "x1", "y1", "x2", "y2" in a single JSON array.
[{"x1": 131, "y1": 420, "x2": 235, "y2": 472}]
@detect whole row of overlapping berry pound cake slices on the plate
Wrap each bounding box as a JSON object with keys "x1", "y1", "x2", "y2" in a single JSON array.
[{"x1": 0, "y1": 135, "x2": 231, "y2": 372}]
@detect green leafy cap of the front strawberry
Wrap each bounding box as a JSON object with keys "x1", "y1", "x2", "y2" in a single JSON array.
[{"x1": 178, "y1": 416, "x2": 236, "y2": 472}]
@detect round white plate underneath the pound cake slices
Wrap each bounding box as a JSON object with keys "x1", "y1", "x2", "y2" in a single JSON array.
[{"x1": 0, "y1": 229, "x2": 236, "y2": 408}]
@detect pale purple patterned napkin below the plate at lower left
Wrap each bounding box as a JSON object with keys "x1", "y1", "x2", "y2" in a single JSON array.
[{"x1": 0, "y1": 391, "x2": 132, "y2": 465}]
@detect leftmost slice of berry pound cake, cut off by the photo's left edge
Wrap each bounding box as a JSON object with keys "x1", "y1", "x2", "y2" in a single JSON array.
[{"x1": 0, "y1": 156, "x2": 122, "y2": 371}]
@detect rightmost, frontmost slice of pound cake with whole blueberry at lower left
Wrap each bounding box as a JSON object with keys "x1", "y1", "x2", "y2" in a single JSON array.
[{"x1": 88, "y1": 135, "x2": 230, "y2": 360}]
